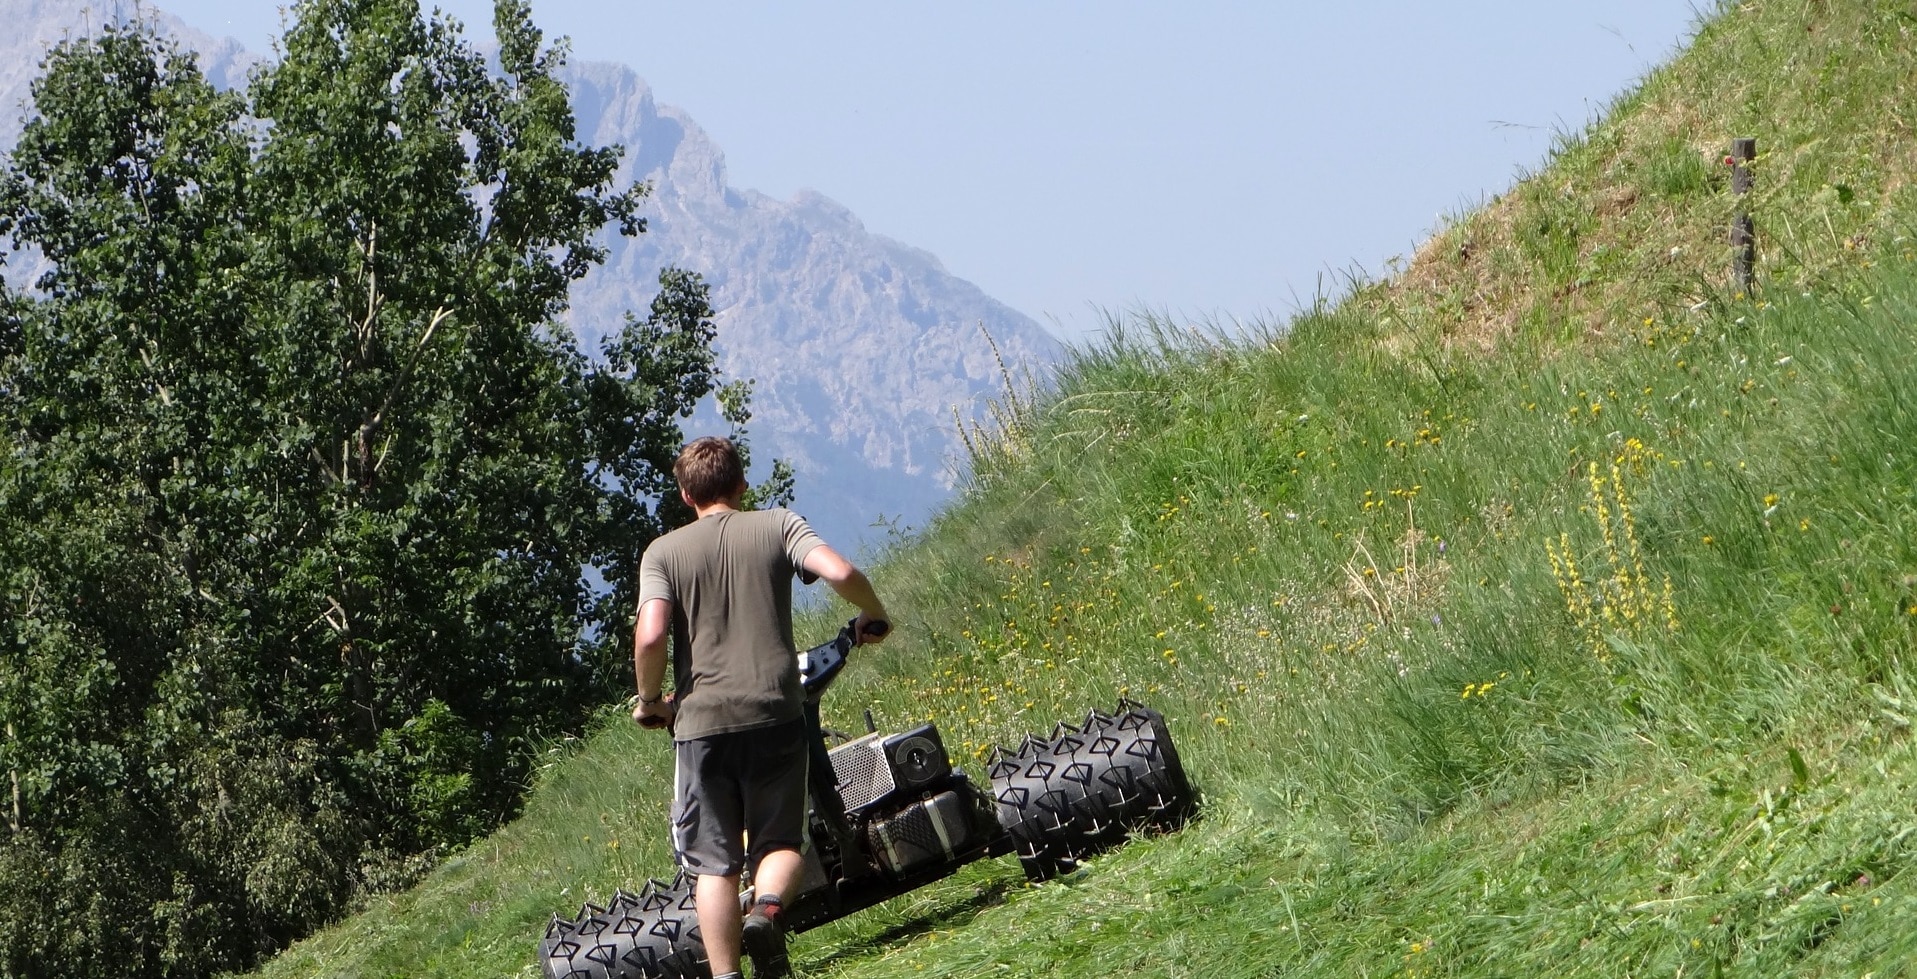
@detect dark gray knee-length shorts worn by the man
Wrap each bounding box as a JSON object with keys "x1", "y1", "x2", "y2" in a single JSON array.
[{"x1": 673, "y1": 718, "x2": 807, "y2": 877}]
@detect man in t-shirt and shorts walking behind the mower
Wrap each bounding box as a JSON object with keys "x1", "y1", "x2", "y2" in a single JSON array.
[{"x1": 633, "y1": 437, "x2": 889, "y2": 979}]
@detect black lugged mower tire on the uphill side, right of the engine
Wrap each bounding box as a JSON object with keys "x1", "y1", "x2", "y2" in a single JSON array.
[{"x1": 989, "y1": 699, "x2": 1198, "y2": 881}]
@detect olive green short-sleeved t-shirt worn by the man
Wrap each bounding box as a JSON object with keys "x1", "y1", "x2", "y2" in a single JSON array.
[{"x1": 638, "y1": 510, "x2": 824, "y2": 741}]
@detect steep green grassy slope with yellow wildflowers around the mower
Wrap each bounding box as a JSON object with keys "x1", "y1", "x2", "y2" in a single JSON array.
[{"x1": 254, "y1": 2, "x2": 1917, "y2": 979}]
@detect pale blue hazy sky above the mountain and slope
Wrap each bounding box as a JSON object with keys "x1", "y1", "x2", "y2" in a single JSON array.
[{"x1": 157, "y1": 0, "x2": 1708, "y2": 339}]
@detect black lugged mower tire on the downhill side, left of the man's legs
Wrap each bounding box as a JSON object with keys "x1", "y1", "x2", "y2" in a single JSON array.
[{"x1": 539, "y1": 874, "x2": 711, "y2": 979}]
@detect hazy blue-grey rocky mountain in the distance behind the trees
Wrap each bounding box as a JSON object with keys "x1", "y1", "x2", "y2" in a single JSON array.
[{"x1": 0, "y1": 0, "x2": 1062, "y2": 550}]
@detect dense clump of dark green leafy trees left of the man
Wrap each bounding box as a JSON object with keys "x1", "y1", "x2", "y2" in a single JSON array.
[{"x1": 0, "y1": 0, "x2": 762, "y2": 975}]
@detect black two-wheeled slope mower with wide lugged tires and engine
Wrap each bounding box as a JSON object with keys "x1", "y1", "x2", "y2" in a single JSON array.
[{"x1": 539, "y1": 623, "x2": 1198, "y2": 979}]
